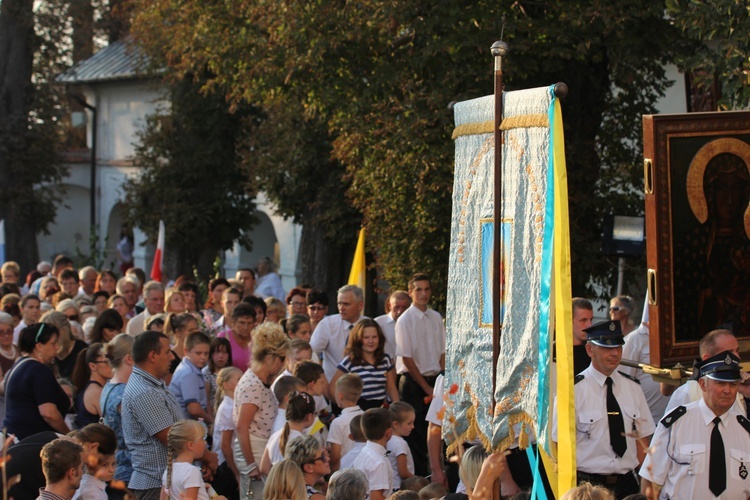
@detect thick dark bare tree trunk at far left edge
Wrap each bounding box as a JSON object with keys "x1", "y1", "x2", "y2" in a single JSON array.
[{"x1": 0, "y1": 0, "x2": 39, "y2": 272}]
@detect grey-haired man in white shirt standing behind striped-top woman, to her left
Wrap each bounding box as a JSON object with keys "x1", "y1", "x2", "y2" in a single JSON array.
[{"x1": 310, "y1": 285, "x2": 365, "y2": 382}]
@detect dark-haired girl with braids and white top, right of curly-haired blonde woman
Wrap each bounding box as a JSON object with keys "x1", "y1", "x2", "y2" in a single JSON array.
[{"x1": 260, "y1": 392, "x2": 315, "y2": 475}]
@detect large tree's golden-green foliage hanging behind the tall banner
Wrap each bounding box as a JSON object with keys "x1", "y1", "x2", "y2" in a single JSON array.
[{"x1": 133, "y1": 0, "x2": 692, "y2": 306}]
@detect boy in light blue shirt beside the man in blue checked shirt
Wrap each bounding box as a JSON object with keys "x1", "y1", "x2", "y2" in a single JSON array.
[{"x1": 169, "y1": 332, "x2": 214, "y2": 424}]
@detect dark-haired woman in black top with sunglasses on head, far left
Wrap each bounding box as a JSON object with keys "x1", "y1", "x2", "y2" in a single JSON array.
[{"x1": 3, "y1": 323, "x2": 70, "y2": 440}]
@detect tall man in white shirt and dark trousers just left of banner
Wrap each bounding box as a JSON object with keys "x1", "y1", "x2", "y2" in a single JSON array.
[{"x1": 396, "y1": 273, "x2": 445, "y2": 476}]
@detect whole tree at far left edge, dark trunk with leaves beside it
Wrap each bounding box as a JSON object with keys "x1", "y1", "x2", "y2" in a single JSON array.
[{"x1": 0, "y1": 0, "x2": 65, "y2": 270}]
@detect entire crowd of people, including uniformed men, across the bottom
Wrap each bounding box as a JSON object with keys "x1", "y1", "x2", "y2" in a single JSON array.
[{"x1": 0, "y1": 256, "x2": 750, "y2": 500}]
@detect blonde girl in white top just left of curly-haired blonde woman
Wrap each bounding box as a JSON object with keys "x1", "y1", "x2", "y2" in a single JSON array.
[{"x1": 211, "y1": 366, "x2": 242, "y2": 498}]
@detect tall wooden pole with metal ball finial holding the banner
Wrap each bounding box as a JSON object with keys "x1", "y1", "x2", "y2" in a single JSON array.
[{"x1": 491, "y1": 41, "x2": 508, "y2": 406}]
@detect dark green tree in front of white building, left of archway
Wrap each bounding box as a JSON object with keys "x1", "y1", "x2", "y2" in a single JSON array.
[{"x1": 124, "y1": 78, "x2": 256, "y2": 278}]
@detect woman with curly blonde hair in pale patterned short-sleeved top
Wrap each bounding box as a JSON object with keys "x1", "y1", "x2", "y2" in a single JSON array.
[{"x1": 233, "y1": 323, "x2": 289, "y2": 498}]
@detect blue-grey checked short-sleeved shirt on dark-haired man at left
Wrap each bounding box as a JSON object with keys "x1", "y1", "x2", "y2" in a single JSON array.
[{"x1": 121, "y1": 366, "x2": 182, "y2": 490}]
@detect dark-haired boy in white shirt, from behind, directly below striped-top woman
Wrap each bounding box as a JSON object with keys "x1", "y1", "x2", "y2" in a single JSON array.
[{"x1": 352, "y1": 408, "x2": 393, "y2": 500}]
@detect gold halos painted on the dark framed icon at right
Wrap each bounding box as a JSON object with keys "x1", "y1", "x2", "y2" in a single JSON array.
[{"x1": 686, "y1": 137, "x2": 750, "y2": 238}]
